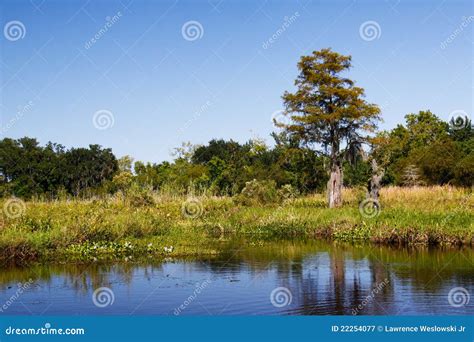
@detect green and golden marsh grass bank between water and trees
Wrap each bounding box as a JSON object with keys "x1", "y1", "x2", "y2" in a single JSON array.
[{"x1": 0, "y1": 187, "x2": 474, "y2": 261}]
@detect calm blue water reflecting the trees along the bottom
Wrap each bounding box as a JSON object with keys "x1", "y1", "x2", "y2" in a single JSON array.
[{"x1": 0, "y1": 242, "x2": 474, "y2": 315}]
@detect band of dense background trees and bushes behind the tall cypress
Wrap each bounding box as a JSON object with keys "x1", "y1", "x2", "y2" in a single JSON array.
[{"x1": 0, "y1": 111, "x2": 474, "y2": 199}]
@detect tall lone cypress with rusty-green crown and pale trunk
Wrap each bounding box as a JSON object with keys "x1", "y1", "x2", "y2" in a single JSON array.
[{"x1": 276, "y1": 49, "x2": 380, "y2": 208}]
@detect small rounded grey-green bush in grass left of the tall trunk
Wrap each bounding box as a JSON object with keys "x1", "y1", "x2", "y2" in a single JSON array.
[{"x1": 236, "y1": 179, "x2": 280, "y2": 206}]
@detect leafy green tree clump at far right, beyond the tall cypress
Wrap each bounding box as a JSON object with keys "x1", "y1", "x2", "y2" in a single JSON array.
[{"x1": 373, "y1": 111, "x2": 474, "y2": 187}]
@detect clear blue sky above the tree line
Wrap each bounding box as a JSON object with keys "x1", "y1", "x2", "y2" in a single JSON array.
[{"x1": 0, "y1": 0, "x2": 474, "y2": 162}]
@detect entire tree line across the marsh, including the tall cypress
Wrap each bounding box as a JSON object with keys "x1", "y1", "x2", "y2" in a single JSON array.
[{"x1": 0, "y1": 49, "x2": 474, "y2": 203}]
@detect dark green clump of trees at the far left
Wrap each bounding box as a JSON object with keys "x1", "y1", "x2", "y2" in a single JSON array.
[{"x1": 0, "y1": 137, "x2": 118, "y2": 198}]
